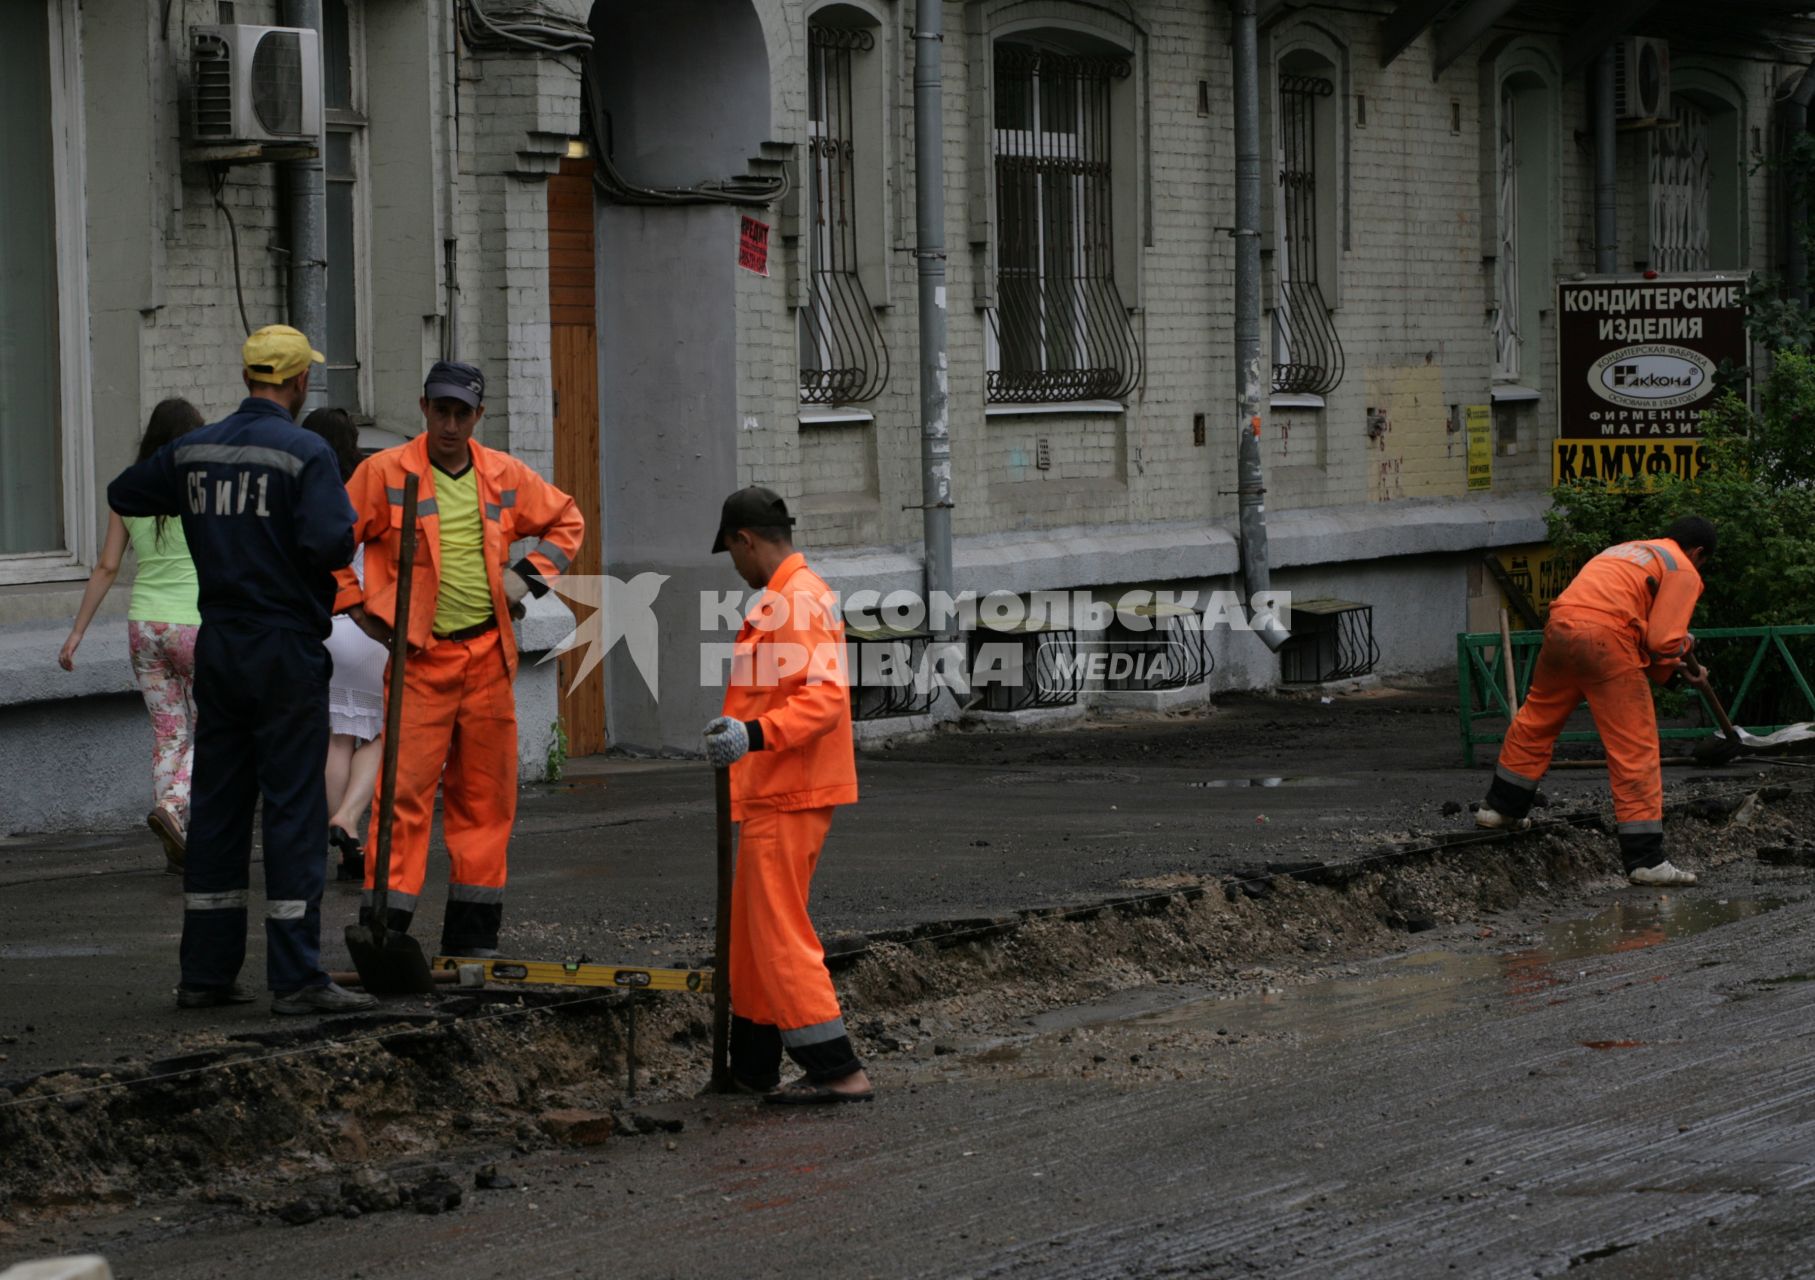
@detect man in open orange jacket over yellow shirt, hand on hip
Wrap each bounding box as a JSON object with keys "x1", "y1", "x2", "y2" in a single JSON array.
[{"x1": 334, "y1": 361, "x2": 586, "y2": 957}]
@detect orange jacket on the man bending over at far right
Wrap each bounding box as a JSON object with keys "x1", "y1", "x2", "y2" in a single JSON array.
[{"x1": 1550, "y1": 537, "x2": 1702, "y2": 679}]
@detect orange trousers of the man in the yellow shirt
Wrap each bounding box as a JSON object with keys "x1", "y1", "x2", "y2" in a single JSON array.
[{"x1": 365, "y1": 630, "x2": 517, "y2": 955}]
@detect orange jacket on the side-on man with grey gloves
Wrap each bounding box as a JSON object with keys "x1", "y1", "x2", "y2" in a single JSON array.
[{"x1": 724, "y1": 552, "x2": 857, "y2": 821}]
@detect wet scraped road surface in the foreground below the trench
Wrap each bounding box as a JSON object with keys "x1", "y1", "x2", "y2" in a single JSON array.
[{"x1": 60, "y1": 864, "x2": 1815, "y2": 1280}]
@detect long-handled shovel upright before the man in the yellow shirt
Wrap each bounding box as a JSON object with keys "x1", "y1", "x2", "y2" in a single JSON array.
[{"x1": 347, "y1": 476, "x2": 434, "y2": 995}]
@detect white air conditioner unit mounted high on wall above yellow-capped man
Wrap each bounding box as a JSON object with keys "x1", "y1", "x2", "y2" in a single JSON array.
[{"x1": 189, "y1": 25, "x2": 321, "y2": 145}]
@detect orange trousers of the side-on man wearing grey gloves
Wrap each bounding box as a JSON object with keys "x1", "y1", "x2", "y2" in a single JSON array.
[{"x1": 731, "y1": 808, "x2": 844, "y2": 1049}]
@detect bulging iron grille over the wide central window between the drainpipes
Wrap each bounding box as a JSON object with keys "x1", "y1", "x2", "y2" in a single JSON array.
[{"x1": 987, "y1": 42, "x2": 1142, "y2": 403}]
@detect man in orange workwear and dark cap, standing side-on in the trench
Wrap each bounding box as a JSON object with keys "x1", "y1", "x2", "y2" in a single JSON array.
[{"x1": 706, "y1": 487, "x2": 875, "y2": 1102}]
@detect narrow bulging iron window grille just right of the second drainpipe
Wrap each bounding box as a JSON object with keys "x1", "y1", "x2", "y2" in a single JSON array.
[{"x1": 1272, "y1": 74, "x2": 1343, "y2": 396}]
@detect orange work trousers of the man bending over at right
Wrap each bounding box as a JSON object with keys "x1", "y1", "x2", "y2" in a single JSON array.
[{"x1": 1488, "y1": 617, "x2": 1664, "y2": 868}]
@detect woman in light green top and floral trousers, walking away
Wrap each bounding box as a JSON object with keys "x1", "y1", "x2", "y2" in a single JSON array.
[{"x1": 56, "y1": 399, "x2": 201, "y2": 871}]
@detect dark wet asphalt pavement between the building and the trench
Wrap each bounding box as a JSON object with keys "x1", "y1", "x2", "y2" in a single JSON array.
[{"x1": 0, "y1": 690, "x2": 1531, "y2": 1082}]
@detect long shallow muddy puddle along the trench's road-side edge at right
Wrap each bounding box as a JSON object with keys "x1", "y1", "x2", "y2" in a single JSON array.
[{"x1": 996, "y1": 895, "x2": 1784, "y2": 1064}]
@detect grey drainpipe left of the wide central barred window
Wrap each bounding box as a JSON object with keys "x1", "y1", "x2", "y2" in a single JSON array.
[{"x1": 913, "y1": 0, "x2": 955, "y2": 641}]
